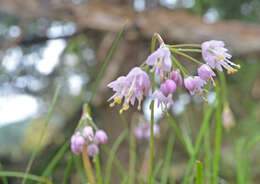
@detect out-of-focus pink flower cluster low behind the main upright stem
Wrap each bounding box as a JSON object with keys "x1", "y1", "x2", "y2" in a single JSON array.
[{"x1": 134, "y1": 123, "x2": 160, "y2": 139}]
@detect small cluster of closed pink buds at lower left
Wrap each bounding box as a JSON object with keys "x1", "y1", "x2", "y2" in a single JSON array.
[{"x1": 71, "y1": 126, "x2": 108, "y2": 157}]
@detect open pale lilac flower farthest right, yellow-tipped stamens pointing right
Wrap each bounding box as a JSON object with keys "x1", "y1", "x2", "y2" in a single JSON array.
[{"x1": 201, "y1": 40, "x2": 240, "y2": 73}]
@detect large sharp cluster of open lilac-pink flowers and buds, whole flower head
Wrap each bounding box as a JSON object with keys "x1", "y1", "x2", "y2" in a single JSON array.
[{"x1": 108, "y1": 40, "x2": 240, "y2": 113}]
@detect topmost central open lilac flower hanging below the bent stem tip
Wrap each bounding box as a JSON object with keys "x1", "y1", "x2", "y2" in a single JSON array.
[{"x1": 146, "y1": 45, "x2": 172, "y2": 76}]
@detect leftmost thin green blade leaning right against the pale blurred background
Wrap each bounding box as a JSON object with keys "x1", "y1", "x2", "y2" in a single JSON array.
[{"x1": 22, "y1": 87, "x2": 60, "y2": 184}]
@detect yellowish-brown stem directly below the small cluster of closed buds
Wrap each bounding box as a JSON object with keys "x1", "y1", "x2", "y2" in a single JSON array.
[{"x1": 82, "y1": 144, "x2": 96, "y2": 184}]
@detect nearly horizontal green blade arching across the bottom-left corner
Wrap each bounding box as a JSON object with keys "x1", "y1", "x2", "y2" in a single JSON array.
[{"x1": 0, "y1": 171, "x2": 52, "y2": 184}]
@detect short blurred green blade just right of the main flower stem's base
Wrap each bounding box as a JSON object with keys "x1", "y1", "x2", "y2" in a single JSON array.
[{"x1": 161, "y1": 134, "x2": 174, "y2": 184}]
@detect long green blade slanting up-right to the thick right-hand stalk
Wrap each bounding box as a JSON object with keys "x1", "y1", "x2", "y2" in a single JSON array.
[{"x1": 182, "y1": 102, "x2": 215, "y2": 184}]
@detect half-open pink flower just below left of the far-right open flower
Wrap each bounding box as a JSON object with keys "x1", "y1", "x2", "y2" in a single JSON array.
[{"x1": 184, "y1": 76, "x2": 205, "y2": 96}]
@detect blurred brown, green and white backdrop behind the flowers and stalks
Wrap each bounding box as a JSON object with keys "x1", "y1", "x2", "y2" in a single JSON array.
[{"x1": 0, "y1": 0, "x2": 260, "y2": 184}]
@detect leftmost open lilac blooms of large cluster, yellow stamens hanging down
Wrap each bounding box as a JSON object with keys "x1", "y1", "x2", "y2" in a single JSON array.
[{"x1": 107, "y1": 67, "x2": 150, "y2": 114}]
